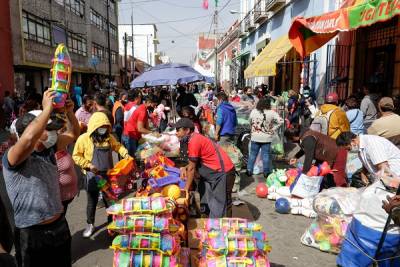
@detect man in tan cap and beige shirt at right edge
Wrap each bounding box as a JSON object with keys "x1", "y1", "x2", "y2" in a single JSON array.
[{"x1": 368, "y1": 97, "x2": 400, "y2": 145}]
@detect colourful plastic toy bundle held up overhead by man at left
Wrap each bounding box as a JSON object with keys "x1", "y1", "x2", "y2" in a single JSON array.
[{"x1": 50, "y1": 43, "x2": 72, "y2": 109}]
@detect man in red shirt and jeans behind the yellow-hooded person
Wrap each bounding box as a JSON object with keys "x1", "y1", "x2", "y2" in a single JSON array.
[{"x1": 122, "y1": 95, "x2": 158, "y2": 157}]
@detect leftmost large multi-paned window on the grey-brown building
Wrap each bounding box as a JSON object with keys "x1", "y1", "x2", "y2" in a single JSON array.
[{"x1": 22, "y1": 11, "x2": 51, "y2": 45}]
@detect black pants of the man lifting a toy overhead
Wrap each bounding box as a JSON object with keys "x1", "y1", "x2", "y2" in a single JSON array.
[{"x1": 15, "y1": 216, "x2": 72, "y2": 267}]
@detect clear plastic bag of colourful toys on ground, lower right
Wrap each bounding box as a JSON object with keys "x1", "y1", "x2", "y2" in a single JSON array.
[{"x1": 301, "y1": 187, "x2": 363, "y2": 253}]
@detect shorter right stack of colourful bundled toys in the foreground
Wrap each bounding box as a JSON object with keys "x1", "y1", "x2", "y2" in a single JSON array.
[{"x1": 192, "y1": 218, "x2": 271, "y2": 267}]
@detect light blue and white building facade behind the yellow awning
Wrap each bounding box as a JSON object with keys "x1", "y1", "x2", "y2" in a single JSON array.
[{"x1": 238, "y1": 0, "x2": 336, "y2": 99}]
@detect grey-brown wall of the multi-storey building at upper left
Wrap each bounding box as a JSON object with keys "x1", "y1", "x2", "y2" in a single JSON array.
[{"x1": 10, "y1": 0, "x2": 119, "y2": 94}]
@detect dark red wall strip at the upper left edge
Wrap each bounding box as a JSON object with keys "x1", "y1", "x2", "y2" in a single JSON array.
[{"x1": 0, "y1": 0, "x2": 14, "y2": 103}]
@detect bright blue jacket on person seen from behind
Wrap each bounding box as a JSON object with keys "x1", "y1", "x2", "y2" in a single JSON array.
[{"x1": 217, "y1": 101, "x2": 237, "y2": 136}]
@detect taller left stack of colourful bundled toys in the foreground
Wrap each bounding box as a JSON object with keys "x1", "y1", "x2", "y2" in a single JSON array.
[{"x1": 107, "y1": 197, "x2": 190, "y2": 267}]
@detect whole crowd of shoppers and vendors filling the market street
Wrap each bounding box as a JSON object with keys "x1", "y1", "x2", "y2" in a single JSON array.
[{"x1": 0, "y1": 82, "x2": 400, "y2": 266}]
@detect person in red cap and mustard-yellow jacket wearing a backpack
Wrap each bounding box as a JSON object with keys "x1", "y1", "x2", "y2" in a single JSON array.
[{"x1": 311, "y1": 93, "x2": 350, "y2": 139}]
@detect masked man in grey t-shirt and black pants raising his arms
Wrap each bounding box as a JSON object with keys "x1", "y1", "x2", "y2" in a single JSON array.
[{"x1": 2, "y1": 91, "x2": 71, "y2": 266}]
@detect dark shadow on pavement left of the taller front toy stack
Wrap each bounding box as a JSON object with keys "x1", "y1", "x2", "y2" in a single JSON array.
[{"x1": 71, "y1": 223, "x2": 109, "y2": 263}]
